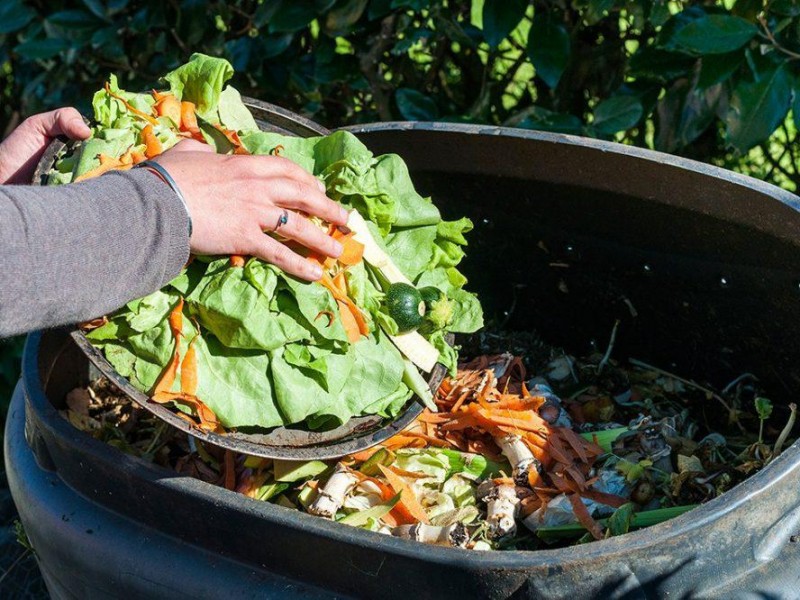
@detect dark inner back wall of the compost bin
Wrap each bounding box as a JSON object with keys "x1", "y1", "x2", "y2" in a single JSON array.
[{"x1": 359, "y1": 126, "x2": 800, "y2": 418}]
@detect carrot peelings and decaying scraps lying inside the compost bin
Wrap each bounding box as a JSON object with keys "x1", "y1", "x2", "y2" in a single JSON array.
[{"x1": 64, "y1": 336, "x2": 795, "y2": 550}]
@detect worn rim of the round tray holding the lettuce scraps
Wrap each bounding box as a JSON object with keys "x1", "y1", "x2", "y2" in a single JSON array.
[{"x1": 33, "y1": 98, "x2": 453, "y2": 460}]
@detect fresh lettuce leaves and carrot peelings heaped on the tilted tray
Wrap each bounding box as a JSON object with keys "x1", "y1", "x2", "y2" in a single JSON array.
[{"x1": 56, "y1": 54, "x2": 483, "y2": 431}]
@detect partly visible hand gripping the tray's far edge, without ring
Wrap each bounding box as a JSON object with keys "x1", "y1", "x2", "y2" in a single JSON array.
[{"x1": 0, "y1": 108, "x2": 92, "y2": 184}]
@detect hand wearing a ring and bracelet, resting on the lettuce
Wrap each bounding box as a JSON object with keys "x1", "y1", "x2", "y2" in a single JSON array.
[{"x1": 155, "y1": 140, "x2": 347, "y2": 281}]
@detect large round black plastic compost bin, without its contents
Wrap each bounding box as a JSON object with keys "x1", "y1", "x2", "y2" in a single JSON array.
[{"x1": 6, "y1": 124, "x2": 800, "y2": 599}]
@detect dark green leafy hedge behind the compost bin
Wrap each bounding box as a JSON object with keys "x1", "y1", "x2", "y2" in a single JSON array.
[{"x1": 0, "y1": 0, "x2": 800, "y2": 418}]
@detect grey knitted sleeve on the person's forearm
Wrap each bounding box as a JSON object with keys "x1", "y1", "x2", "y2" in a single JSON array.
[{"x1": 0, "y1": 169, "x2": 189, "y2": 338}]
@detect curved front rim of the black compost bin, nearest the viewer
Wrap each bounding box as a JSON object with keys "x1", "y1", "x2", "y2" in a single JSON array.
[{"x1": 22, "y1": 331, "x2": 800, "y2": 569}]
